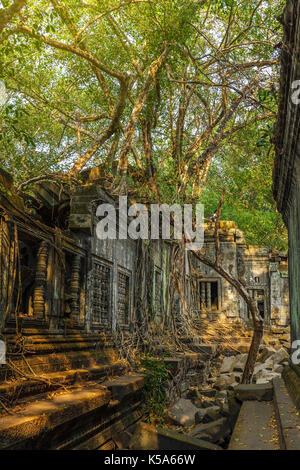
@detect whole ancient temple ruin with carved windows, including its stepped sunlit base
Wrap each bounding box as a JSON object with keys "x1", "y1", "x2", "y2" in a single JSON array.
[{"x1": 0, "y1": 167, "x2": 288, "y2": 449}]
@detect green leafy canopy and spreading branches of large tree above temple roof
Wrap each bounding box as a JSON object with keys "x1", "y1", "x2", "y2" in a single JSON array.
[{"x1": 0, "y1": 0, "x2": 281, "y2": 201}]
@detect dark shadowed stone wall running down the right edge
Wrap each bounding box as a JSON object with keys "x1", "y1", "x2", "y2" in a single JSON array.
[{"x1": 273, "y1": 0, "x2": 300, "y2": 341}]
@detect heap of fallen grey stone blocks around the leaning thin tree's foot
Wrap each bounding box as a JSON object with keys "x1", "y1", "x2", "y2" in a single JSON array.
[{"x1": 163, "y1": 341, "x2": 289, "y2": 448}]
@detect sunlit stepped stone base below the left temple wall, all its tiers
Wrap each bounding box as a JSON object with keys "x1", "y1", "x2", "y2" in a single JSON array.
[{"x1": 0, "y1": 331, "x2": 144, "y2": 449}]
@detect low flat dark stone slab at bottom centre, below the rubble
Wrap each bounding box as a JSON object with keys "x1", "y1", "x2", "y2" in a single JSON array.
[{"x1": 130, "y1": 423, "x2": 222, "y2": 450}]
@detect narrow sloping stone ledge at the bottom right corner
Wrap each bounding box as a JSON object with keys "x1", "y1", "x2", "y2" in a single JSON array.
[{"x1": 273, "y1": 377, "x2": 300, "y2": 450}]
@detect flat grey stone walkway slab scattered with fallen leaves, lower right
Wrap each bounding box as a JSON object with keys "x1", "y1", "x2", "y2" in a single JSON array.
[{"x1": 228, "y1": 401, "x2": 280, "y2": 450}]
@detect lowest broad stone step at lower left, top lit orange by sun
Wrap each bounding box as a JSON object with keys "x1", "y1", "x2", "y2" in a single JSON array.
[{"x1": 0, "y1": 375, "x2": 144, "y2": 450}]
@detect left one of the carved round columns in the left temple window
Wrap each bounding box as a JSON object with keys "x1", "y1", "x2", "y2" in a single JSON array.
[{"x1": 33, "y1": 241, "x2": 49, "y2": 318}]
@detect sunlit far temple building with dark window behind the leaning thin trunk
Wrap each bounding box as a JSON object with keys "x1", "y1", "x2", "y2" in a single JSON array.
[{"x1": 195, "y1": 221, "x2": 289, "y2": 326}]
